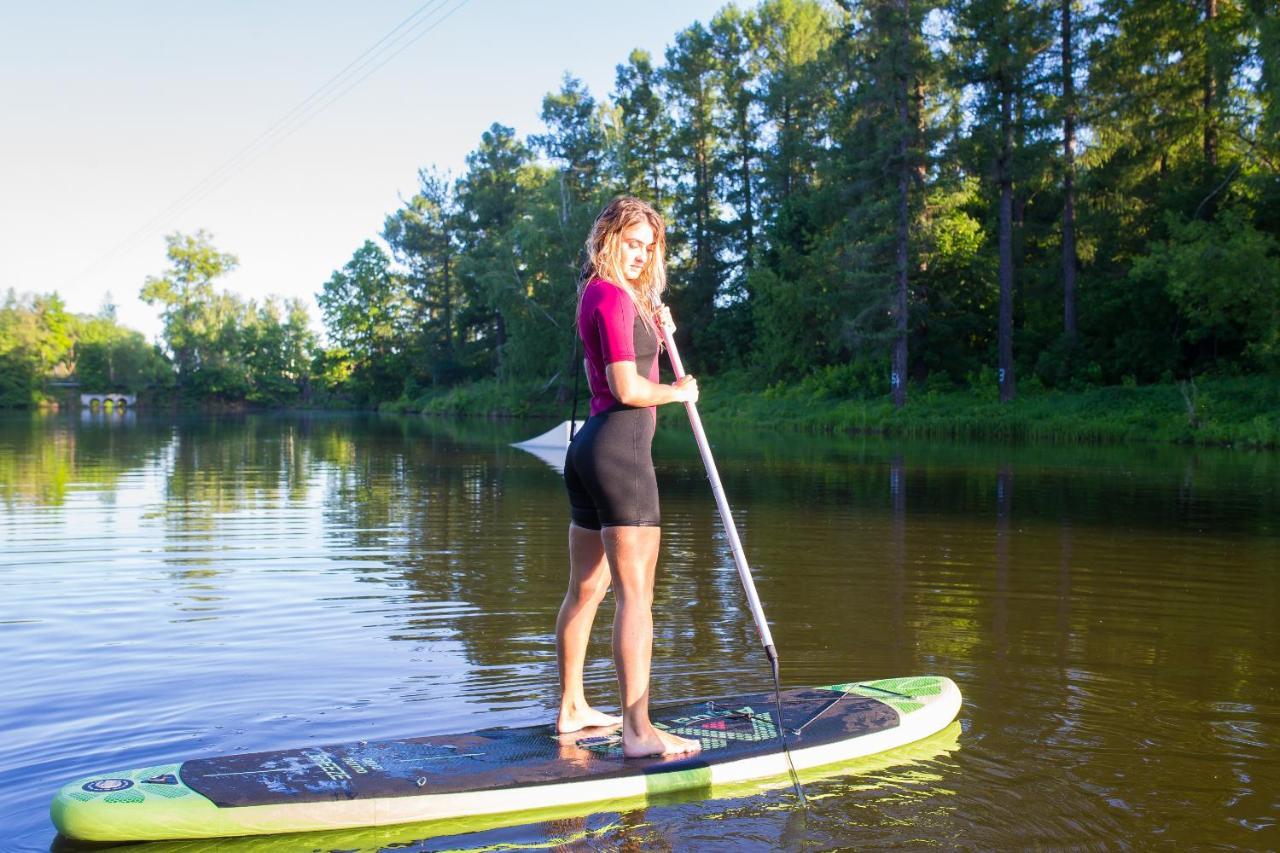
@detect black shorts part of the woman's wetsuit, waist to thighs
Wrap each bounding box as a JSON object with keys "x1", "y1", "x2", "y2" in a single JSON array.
[{"x1": 564, "y1": 403, "x2": 662, "y2": 530}]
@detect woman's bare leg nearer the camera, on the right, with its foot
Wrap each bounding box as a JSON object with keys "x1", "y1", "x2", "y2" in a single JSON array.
[{"x1": 603, "y1": 526, "x2": 701, "y2": 758}]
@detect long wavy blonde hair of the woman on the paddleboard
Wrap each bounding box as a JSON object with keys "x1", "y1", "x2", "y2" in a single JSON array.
[{"x1": 577, "y1": 196, "x2": 667, "y2": 327}]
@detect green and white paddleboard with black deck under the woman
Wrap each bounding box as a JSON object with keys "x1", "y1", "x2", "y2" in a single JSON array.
[{"x1": 51, "y1": 676, "x2": 960, "y2": 841}]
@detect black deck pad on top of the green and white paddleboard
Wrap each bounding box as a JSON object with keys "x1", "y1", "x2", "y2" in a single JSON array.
[{"x1": 179, "y1": 689, "x2": 899, "y2": 808}]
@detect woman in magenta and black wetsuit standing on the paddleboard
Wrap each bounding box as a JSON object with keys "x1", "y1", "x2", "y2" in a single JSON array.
[{"x1": 556, "y1": 197, "x2": 700, "y2": 757}]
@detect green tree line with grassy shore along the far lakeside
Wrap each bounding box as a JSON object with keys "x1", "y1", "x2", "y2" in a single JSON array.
[{"x1": 0, "y1": 0, "x2": 1280, "y2": 447}]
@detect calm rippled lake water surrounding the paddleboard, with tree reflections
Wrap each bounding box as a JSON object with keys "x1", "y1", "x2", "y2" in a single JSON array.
[{"x1": 0, "y1": 412, "x2": 1280, "y2": 853}]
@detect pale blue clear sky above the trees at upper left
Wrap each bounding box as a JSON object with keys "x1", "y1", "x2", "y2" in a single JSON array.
[{"x1": 0, "y1": 0, "x2": 724, "y2": 339}]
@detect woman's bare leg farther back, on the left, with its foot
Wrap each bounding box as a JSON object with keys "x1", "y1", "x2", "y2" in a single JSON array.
[{"x1": 556, "y1": 524, "x2": 622, "y2": 731}]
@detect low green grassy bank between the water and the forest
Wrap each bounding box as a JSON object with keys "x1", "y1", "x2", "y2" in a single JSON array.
[{"x1": 383, "y1": 377, "x2": 1280, "y2": 448}]
